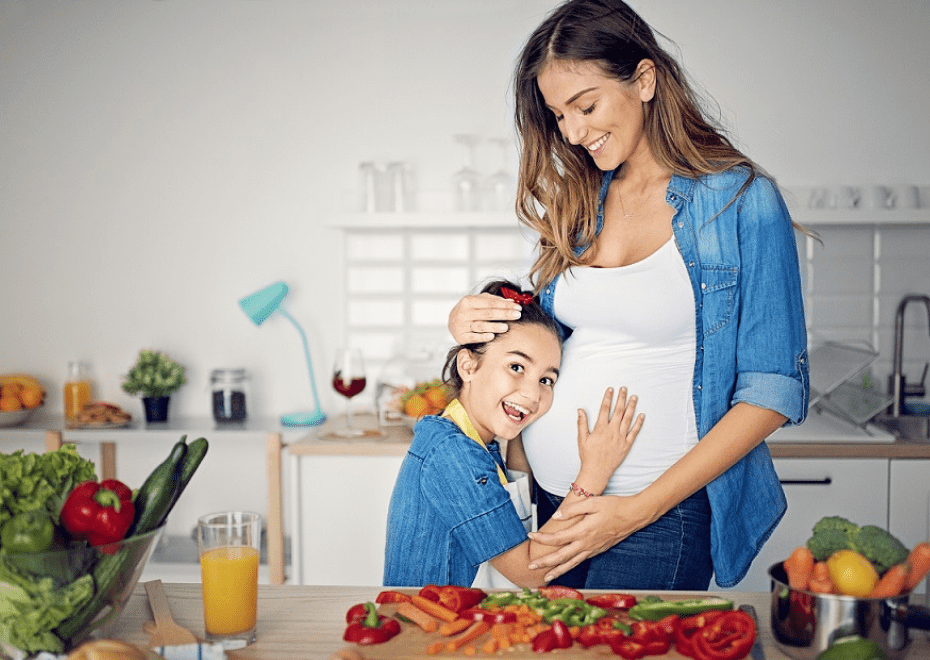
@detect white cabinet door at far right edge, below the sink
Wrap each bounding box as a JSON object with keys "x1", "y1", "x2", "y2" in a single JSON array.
[{"x1": 888, "y1": 460, "x2": 930, "y2": 593}]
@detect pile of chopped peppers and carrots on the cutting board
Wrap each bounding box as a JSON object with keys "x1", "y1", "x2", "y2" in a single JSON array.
[{"x1": 344, "y1": 585, "x2": 757, "y2": 660}]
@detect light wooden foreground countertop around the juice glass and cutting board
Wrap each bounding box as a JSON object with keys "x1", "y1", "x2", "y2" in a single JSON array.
[{"x1": 107, "y1": 584, "x2": 930, "y2": 660}]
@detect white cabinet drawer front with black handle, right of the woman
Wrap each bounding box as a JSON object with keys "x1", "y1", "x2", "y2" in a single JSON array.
[{"x1": 735, "y1": 458, "x2": 884, "y2": 591}]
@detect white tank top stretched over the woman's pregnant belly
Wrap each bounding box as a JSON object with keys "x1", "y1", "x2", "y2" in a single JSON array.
[{"x1": 523, "y1": 239, "x2": 698, "y2": 495}]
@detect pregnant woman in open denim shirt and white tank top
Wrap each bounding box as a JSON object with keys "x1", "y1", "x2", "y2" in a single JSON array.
[{"x1": 449, "y1": 0, "x2": 809, "y2": 590}]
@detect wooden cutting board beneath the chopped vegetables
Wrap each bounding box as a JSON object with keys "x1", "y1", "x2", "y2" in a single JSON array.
[{"x1": 331, "y1": 604, "x2": 688, "y2": 660}]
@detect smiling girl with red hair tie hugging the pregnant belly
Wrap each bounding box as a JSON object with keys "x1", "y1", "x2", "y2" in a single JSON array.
[{"x1": 384, "y1": 282, "x2": 643, "y2": 587}]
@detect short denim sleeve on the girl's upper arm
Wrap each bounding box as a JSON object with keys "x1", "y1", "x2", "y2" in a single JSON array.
[{"x1": 421, "y1": 441, "x2": 527, "y2": 566}]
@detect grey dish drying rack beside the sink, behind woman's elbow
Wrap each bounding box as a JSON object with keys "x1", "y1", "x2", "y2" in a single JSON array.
[{"x1": 809, "y1": 341, "x2": 893, "y2": 435}]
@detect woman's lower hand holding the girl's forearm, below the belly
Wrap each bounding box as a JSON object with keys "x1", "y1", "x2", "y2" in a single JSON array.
[{"x1": 529, "y1": 495, "x2": 652, "y2": 582}]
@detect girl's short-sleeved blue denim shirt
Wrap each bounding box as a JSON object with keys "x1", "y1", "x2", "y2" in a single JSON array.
[{"x1": 384, "y1": 415, "x2": 527, "y2": 587}]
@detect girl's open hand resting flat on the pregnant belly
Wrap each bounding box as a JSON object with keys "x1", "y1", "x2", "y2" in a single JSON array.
[{"x1": 577, "y1": 387, "x2": 645, "y2": 494}]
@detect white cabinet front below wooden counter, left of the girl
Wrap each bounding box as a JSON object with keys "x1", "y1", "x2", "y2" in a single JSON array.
[{"x1": 288, "y1": 454, "x2": 404, "y2": 586}]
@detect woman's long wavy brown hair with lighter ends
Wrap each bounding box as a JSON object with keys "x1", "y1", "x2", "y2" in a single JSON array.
[{"x1": 514, "y1": 0, "x2": 796, "y2": 291}]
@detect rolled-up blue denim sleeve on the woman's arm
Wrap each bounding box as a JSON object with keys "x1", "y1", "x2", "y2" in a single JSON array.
[{"x1": 733, "y1": 178, "x2": 810, "y2": 425}]
